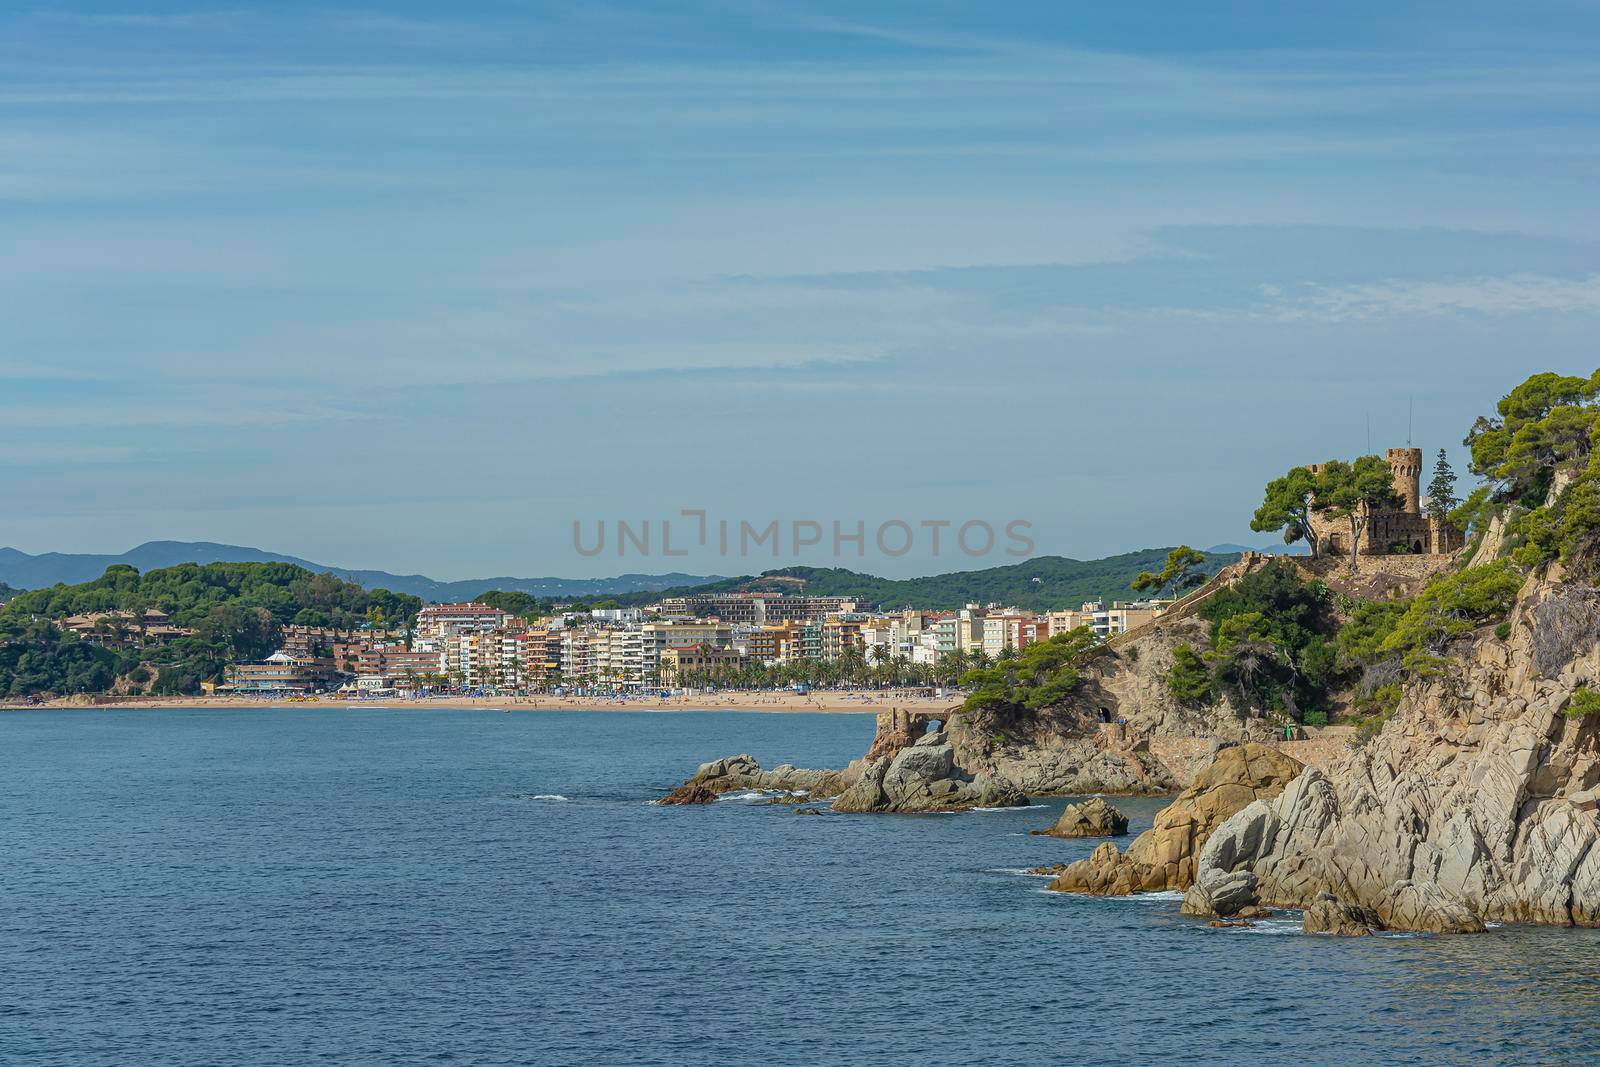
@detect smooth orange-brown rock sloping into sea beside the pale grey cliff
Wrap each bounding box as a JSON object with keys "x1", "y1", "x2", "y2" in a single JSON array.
[{"x1": 1050, "y1": 742, "x2": 1302, "y2": 896}]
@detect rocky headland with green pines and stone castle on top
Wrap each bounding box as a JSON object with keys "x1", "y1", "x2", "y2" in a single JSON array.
[{"x1": 664, "y1": 371, "x2": 1600, "y2": 934}]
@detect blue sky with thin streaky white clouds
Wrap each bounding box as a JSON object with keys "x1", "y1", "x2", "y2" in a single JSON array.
[{"x1": 0, "y1": 2, "x2": 1600, "y2": 577}]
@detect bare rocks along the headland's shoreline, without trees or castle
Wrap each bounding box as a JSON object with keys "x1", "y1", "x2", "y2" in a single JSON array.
[{"x1": 662, "y1": 577, "x2": 1600, "y2": 936}]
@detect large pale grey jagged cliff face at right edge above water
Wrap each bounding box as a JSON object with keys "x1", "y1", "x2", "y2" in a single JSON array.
[{"x1": 1190, "y1": 581, "x2": 1600, "y2": 931}]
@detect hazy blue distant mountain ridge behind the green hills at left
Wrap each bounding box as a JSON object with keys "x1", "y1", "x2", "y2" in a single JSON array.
[{"x1": 0, "y1": 541, "x2": 723, "y2": 603}]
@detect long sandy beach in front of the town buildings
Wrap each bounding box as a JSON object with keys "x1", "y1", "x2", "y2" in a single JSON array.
[{"x1": 0, "y1": 689, "x2": 960, "y2": 715}]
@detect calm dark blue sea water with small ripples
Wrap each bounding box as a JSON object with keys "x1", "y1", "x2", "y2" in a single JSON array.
[{"x1": 0, "y1": 709, "x2": 1600, "y2": 1067}]
